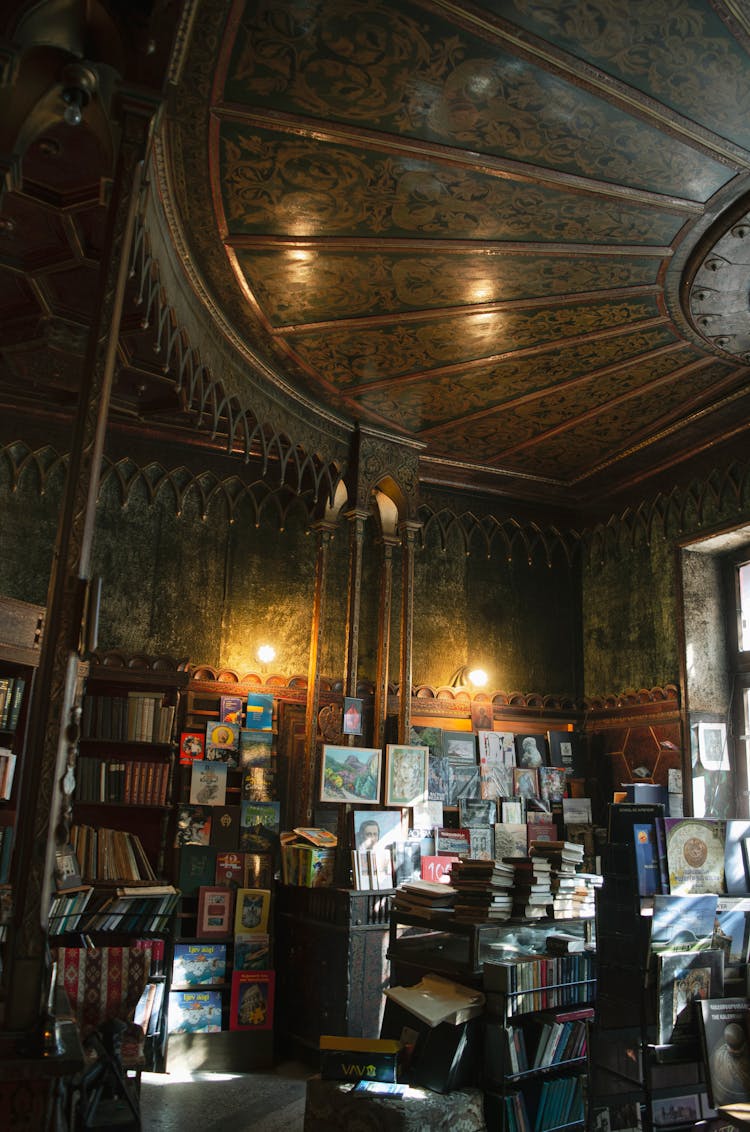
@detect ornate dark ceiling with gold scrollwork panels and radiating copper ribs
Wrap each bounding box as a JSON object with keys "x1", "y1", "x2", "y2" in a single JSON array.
[{"x1": 0, "y1": 0, "x2": 750, "y2": 518}]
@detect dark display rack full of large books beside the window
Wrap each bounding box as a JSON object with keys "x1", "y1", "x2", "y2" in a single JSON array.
[{"x1": 589, "y1": 800, "x2": 750, "y2": 1130}]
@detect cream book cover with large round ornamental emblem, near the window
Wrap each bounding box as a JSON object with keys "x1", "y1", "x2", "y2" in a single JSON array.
[{"x1": 664, "y1": 817, "x2": 725, "y2": 893}]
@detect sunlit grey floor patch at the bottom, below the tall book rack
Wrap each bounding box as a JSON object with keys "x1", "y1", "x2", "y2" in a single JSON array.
[{"x1": 140, "y1": 1062, "x2": 314, "y2": 1132}]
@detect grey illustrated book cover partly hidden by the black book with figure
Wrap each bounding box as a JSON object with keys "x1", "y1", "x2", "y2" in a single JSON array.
[{"x1": 656, "y1": 949, "x2": 724, "y2": 1045}]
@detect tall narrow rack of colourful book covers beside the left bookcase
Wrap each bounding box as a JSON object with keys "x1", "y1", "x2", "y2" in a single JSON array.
[{"x1": 169, "y1": 686, "x2": 281, "y2": 1070}]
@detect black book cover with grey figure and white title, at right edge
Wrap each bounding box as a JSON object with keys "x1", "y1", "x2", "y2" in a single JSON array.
[{"x1": 699, "y1": 998, "x2": 750, "y2": 1108}]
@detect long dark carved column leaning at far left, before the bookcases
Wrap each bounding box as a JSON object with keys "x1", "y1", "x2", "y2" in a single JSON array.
[{"x1": 3, "y1": 96, "x2": 157, "y2": 1032}]
